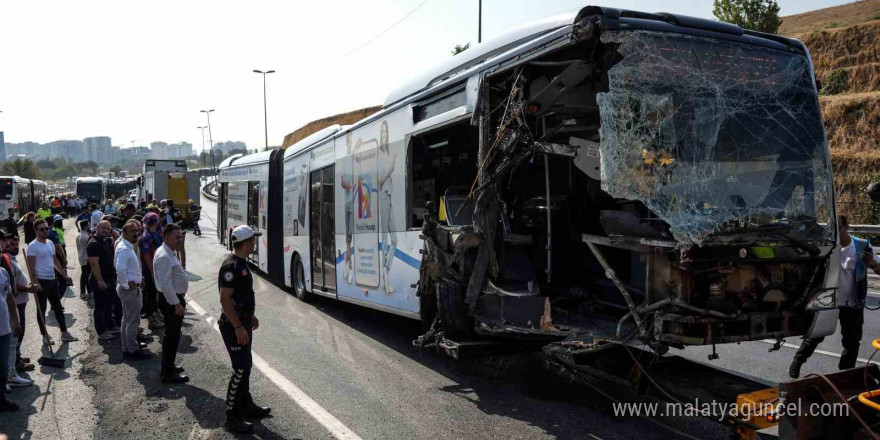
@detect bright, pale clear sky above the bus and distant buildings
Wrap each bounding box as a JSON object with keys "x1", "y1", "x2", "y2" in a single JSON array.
[{"x1": 0, "y1": 0, "x2": 849, "y2": 150}]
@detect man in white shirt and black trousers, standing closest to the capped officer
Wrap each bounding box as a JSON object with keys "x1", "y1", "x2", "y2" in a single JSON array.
[{"x1": 153, "y1": 223, "x2": 189, "y2": 383}]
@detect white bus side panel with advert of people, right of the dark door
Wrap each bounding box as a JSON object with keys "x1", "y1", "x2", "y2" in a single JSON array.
[{"x1": 335, "y1": 111, "x2": 421, "y2": 312}]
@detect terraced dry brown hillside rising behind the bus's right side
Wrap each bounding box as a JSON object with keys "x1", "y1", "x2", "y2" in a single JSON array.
[{"x1": 780, "y1": 0, "x2": 880, "y2": 223}]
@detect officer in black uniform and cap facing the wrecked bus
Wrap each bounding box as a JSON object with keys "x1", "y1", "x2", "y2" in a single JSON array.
[{"x1": 217, "y1": 225, "x2": 272, "y2": 432}]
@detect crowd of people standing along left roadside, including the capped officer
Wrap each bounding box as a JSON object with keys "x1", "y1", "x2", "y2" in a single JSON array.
[{"x1": 0, "y1": 198, "x2": 271, "y2": 432}]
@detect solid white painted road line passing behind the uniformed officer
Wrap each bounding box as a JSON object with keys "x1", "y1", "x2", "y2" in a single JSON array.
[{"x1": 187, "y1": 300, "x2": 362, "y2": 440}]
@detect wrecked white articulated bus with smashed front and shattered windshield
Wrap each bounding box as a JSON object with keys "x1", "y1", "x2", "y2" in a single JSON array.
[{"x1": 218, "y1": 7, "x2": 838, "y2": 352}]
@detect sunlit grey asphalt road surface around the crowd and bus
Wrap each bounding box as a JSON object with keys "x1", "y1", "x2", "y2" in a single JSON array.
[{"x1": 0, "y1": 201, "x2": 880, "y2": 440}]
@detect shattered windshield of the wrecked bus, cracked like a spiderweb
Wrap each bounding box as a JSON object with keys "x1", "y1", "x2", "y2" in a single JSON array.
[{"x1": 598, "y1": 31, "x2": 834, "y2": 245}]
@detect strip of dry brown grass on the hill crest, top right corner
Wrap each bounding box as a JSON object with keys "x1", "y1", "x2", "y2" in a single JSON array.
[{"x1": 778, "y1": 0, "x2": 880, "y2": 35}]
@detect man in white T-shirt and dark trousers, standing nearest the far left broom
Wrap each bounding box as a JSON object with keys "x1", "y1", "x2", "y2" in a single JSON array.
[{"x1": 27, "y1": 219, "x2": 78, "y2": 345}]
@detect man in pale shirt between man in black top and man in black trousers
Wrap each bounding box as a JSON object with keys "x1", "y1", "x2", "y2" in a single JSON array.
[{"x1": 113, "y1": 220, "x2": 150, "y2": 359}]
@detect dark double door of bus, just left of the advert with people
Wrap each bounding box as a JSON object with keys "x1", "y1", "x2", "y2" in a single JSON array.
[{"x1": 309, "y1": 165, "x2": 336, "y2": 292}]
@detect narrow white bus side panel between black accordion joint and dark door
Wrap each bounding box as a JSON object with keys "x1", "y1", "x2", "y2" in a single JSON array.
[{"x1": 283, "y1": 154, "x2": 312, "y2": 287}]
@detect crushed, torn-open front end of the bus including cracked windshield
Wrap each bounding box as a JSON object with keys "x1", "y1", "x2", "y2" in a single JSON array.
[{"x1": 418, "y1": 7, "x2": 837, "y2": 351}]
